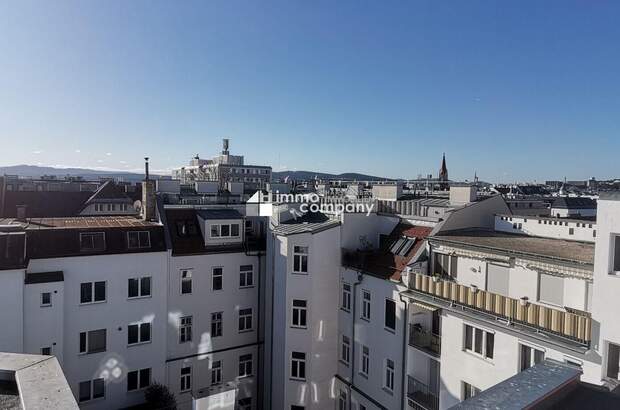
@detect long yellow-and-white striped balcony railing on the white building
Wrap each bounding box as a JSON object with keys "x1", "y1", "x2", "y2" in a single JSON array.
[{"x1": 409, "y1": 273, "x2": 592, "y2": 346}]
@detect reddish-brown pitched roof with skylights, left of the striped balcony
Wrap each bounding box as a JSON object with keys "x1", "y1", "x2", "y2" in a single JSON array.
[{"x1": 343, "y1": 222, "x2": 432, "y2": 281}]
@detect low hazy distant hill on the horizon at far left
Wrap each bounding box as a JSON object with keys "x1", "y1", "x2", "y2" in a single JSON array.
[{"x1": 0, "y1": 165, "x2": 163, "y2": 181}]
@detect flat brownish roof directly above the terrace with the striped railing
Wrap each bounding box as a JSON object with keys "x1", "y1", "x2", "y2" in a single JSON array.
[{"x1": 429, "y1": 229, "x2": 594, "y2": 265}]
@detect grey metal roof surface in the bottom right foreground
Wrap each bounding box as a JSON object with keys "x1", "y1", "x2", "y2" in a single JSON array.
[{"x1": 450, "y1": 359, "x2": 582, "y2": 410}]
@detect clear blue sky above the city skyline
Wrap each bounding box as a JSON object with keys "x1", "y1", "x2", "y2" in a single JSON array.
[{"x1": 0, "y1": 0, "x2": 620, "y2": 182}]
